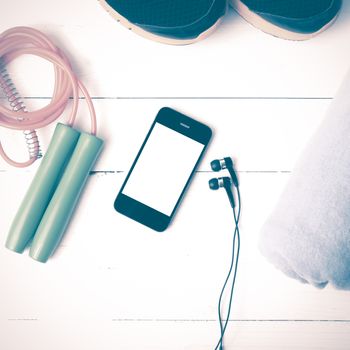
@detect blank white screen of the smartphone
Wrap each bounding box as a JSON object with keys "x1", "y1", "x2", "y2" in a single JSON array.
[{"x1": 122, "y1": 123, "x2": 204, "y2": 216}]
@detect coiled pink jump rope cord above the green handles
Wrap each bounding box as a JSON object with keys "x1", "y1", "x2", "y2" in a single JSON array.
[{"x1": 0, "y1": 27, "x2": 96, "y2": 167}]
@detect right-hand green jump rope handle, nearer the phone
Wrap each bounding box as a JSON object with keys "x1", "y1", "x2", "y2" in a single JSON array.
[{"x1": 29, "y1": 133, "x2": 103, "y2": 262}]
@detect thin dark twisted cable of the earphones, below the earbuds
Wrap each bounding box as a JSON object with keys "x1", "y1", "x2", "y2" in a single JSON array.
[{"x1": 215, "y1": 187, "x2": 241, "y2": 350}]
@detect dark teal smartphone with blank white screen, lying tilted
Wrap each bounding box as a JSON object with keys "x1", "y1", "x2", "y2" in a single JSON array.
[{"x1": 114, "y1": 107, "x2": 212, "y2": 232}]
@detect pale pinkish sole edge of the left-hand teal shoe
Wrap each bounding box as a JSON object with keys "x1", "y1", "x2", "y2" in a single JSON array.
[{"x1": 98, "y1": 0, "x2": 223, "y2": 45}]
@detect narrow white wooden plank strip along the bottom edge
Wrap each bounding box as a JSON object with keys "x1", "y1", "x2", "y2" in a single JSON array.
[{"x1": 0, "y1": 318, "x2": 350, "y2": 350}]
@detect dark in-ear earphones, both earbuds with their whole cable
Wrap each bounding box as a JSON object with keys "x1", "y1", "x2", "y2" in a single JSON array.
[{"x1": 209, "y1": 157, "x2": 241, "y2": 350}]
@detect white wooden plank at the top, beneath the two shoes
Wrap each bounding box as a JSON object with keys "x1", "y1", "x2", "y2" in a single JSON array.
[{"x1": 0, "y1": 0, "x2": 350, "y2": 97}]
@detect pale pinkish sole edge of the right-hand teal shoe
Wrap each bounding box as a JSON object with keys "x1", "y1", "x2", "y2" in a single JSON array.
[{"x1": 230, "y1": 0, "x2": 339, "y2": 41}]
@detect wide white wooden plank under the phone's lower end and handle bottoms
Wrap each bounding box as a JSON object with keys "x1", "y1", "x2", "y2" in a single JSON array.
[{"x1": 0, "y1": 172, "x2": 350, "y2": 320}]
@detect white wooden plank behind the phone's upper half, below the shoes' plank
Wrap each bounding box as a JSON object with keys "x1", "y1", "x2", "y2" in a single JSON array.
[{"x1": 0, "y1": 99, "x2": 331, "y2": 171}]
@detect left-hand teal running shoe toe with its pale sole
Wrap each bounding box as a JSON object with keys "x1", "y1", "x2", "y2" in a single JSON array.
[{"x1": 100, "y1": 0, "x2": 228, "y2": 45}]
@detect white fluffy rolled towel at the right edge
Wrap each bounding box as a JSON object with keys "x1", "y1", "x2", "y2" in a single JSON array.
[{"x1": 259, "y1": 73, "x2": 350, "y2": 289}]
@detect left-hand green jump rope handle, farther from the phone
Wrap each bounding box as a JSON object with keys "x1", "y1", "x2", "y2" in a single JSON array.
[{"x1": 6, "y1": 124, "x2": 80, "y2": 253}]
